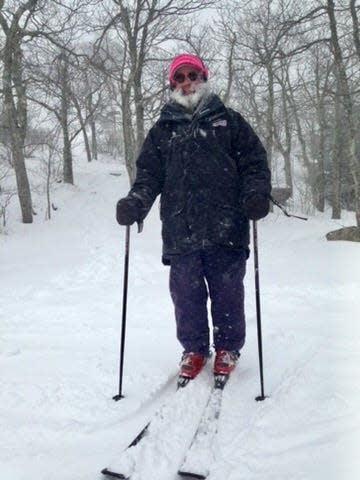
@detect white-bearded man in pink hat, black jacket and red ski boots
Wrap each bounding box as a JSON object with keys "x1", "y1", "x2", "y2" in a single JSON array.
[{"x1": 116, "y1": 53, "x2": 271, "y2": 380}]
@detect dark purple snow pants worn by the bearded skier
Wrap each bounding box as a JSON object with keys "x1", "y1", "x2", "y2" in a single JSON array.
[{"x1": 170, "y1": 248, "x2": 246, "y2": 355}]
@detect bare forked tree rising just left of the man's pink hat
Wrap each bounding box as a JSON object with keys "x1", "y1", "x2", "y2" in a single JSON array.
[{"x1": 99, "y1": 0, "x2": 214, "y2": 181}]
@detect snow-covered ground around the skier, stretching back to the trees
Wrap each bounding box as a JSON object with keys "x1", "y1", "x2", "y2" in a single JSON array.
[{"x1": 0, "y1": 156, "x2": 360, "y2": 480}]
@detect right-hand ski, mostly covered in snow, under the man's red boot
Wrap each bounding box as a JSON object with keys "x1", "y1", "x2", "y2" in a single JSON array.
[{"x1": 178, "y1": 375, "x2": 229, "y2": 480}]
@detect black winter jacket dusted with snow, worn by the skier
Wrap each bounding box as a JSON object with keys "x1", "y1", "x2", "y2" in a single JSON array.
[{"x1": 127, "y1": 94, "x2": 271, "y2": 263}]
